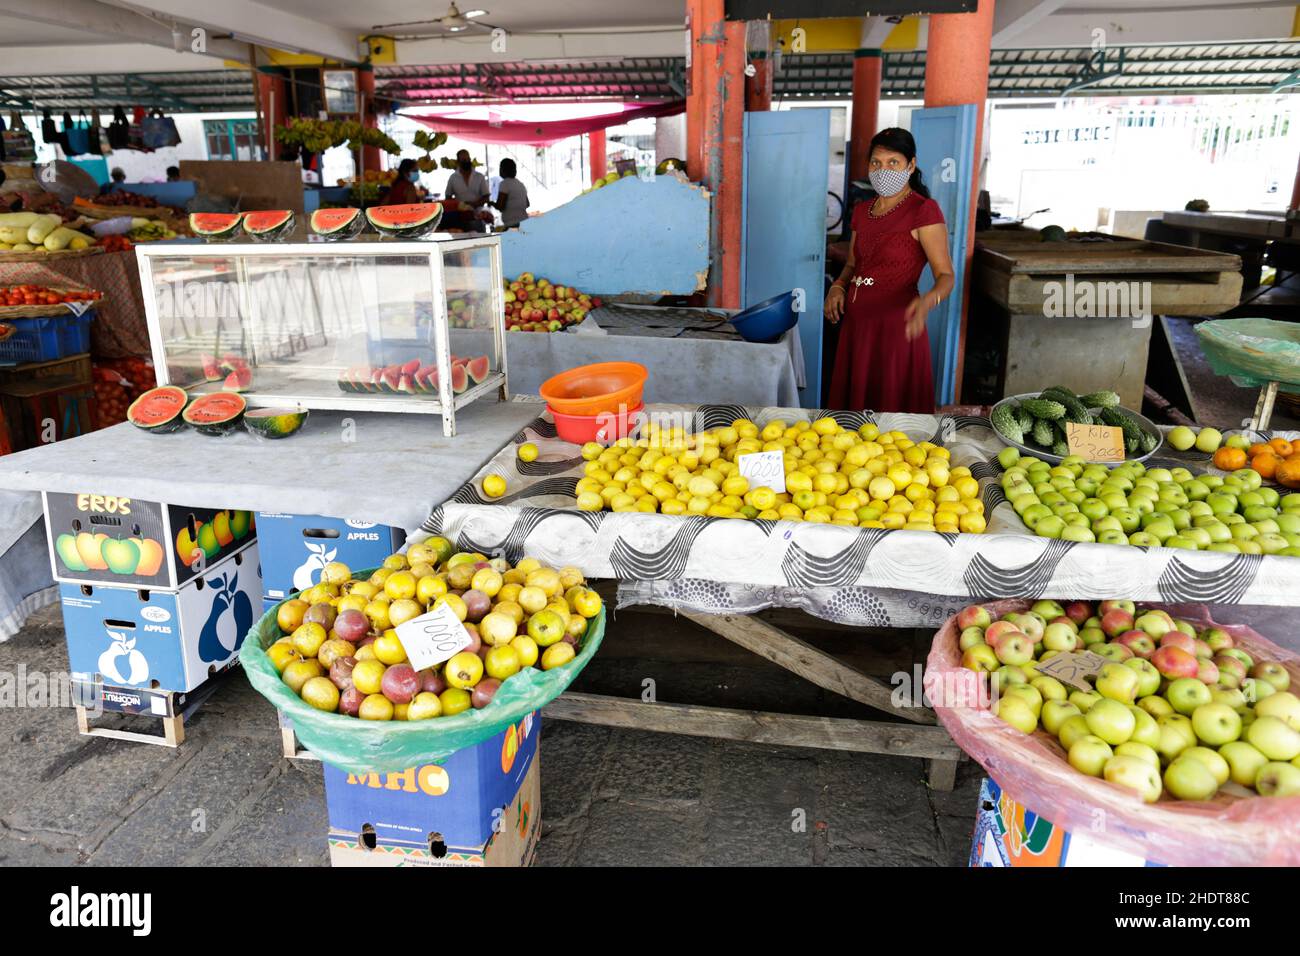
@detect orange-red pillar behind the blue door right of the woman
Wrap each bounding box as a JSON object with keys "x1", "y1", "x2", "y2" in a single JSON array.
[{"x1": 926, "y1": 0, "x2": 995, "y2": 401}]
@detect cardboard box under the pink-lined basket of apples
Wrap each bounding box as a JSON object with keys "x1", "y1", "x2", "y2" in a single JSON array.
[{"x1": 970, "y1": 778, "x2": 1164, "y2": 866}]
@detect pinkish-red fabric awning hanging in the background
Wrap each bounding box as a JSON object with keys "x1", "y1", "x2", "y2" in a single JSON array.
[{"x1": 402, "y1": 100, "x2": 686, "y2": 146}]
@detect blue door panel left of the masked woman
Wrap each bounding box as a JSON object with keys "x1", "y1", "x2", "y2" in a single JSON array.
[{"x1": 740, "y1": 109, "x2": 831, "y2": 408}]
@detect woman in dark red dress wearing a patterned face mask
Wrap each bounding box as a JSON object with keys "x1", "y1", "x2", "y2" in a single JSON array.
[{"x1": 826, "y1": 129, "x2": 953, "y2": 414}]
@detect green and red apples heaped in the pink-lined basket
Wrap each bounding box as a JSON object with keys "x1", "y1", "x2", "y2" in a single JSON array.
[{"x1": 957, "y1": 601, "x2": 1300, "y2": 803}]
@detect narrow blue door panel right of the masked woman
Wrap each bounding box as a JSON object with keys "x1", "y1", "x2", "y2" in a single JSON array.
[{"x1": 911, "y1": 103, "x2": 976, "y2": 405}]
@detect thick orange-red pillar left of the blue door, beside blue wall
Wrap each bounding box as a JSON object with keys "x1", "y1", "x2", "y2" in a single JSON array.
[{"x1": 686, "y1": 0, "x2": 745, "y2": 308}]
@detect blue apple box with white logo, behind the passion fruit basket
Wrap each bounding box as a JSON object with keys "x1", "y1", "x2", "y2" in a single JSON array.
[{"x1": 249, "y1": 511, "x2": 406, "y2": 601}]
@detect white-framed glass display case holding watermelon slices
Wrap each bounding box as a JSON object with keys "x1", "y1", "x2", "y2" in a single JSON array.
[{"x1": 135, "y1": 234, "x2": 508, "y2": 436}]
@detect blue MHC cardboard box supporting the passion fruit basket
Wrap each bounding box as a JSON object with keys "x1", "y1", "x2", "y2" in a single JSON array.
[{"x1": 324, "y1": 713, "x2": 541, "y2": 866}]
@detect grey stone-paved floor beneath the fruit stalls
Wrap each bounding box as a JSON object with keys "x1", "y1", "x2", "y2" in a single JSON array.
[{"x1": 0, "y1": 606, "x2": 980, "y2": 866}]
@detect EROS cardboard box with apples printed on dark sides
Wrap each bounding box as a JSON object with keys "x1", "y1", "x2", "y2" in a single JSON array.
[{"x1": 43, "y1": 492, "x2": 257, "y2": 591}]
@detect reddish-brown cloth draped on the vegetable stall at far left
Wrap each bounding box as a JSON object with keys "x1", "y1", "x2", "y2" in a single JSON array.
[{"x1": 0, "y1": 252, "x2": 150, "y2": 359}]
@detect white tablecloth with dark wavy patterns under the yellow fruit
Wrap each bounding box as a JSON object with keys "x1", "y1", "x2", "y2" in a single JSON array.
[{"x1": 421, "y1": 406, "x2": 1300, "y2": 627}]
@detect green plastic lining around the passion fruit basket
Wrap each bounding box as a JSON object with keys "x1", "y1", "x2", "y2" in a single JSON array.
[{"x1": 239, "y1": 595, "x2": 605, "y2": 774}]
